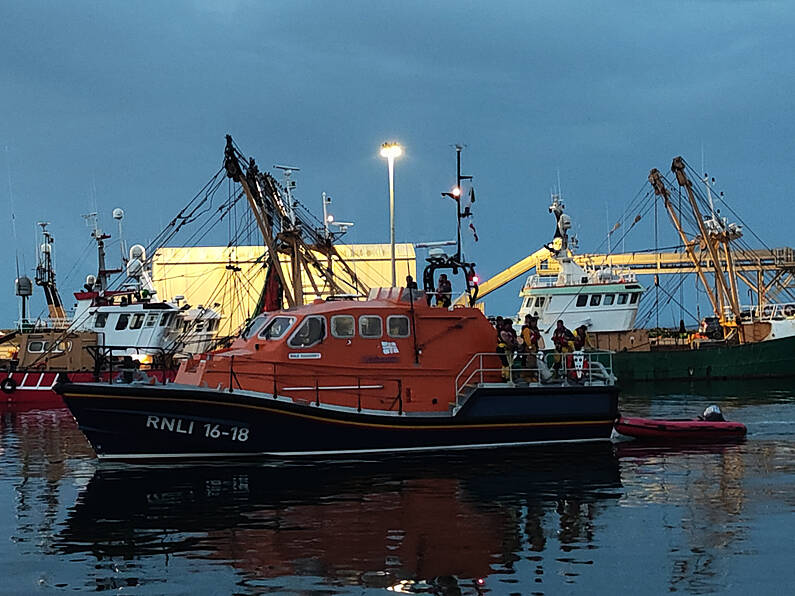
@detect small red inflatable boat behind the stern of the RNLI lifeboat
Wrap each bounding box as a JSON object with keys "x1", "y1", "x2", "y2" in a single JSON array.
[{"x1": 615, "y1": 417, "x2": 747, "y2": 441}]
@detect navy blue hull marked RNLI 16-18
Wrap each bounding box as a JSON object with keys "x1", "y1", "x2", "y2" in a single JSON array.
[{"x1": 58, "y1": 383, "x2": 618, "y2": 459}]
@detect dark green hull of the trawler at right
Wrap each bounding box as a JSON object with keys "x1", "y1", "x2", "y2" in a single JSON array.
[{"x1": 613, "y1": 337, "x2": 795, "y2": 384}]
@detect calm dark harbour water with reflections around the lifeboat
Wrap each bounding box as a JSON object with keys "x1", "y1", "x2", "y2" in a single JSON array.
[{"x1": 0, "y1": 382, "x2": 795, "y2": 594}]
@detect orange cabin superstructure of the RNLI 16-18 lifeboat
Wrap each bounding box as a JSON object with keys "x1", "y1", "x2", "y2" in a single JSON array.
[{"x1": 176, "y1": 288, "x2": 496, "y2": 410}]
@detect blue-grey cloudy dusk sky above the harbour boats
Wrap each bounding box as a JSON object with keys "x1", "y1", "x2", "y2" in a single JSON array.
[{"x1": 0, "y1": 0, "x2": 795, "y2": 327}]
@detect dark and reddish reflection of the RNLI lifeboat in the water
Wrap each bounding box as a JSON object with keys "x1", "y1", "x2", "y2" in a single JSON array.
[{"x1": 55, "y1": 445, "x2": 620, "y2": 593}]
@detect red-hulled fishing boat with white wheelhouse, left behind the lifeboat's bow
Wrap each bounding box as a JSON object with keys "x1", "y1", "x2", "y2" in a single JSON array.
[{"x1": 0, "y1": 214, "x2": 220, "y2": 408}]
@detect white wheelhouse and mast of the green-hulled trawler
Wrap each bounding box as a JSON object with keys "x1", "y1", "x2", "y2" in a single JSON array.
[{"x1": 517, "y1": 195, "x2": 644, "y2": 340}]
